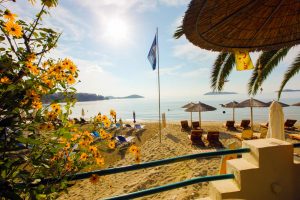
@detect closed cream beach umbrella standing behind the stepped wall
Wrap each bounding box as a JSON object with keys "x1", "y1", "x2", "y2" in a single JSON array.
[{"x1": 267, "y1": 101, "x2": 285, "y2": 140}]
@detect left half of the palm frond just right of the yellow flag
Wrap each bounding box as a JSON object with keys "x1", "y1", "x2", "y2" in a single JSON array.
[{"x1": 248, "y1": 50, "x2": 278, "y2": 95}]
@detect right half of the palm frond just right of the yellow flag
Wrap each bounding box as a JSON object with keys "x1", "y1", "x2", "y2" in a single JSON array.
[{"x1": 250, "y1": 47, "x2": 291, "y2": 95}]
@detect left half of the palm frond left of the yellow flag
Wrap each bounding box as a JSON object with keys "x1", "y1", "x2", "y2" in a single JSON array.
[{"x1": 210, "y1": 52, "x2": 229, "y2": 91}]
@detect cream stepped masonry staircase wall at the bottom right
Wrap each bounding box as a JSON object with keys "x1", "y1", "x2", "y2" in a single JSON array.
[{"x1": 198, "y1": 138, "x2": 300, "y2": 200}]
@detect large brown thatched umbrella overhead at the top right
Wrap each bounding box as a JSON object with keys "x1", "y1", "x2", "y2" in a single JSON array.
[{"x1": 179, "y1": 0, "x2": 300, "y2": 51}]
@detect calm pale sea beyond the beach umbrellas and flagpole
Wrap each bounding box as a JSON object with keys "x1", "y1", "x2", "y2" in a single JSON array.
[{"x1": 70, "y1": 92, "x2": 300, "y2": 122}]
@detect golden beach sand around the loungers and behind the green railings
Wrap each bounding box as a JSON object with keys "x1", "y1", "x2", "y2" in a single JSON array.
[{"x1": 59, "y1": 122, "x2": 295, "y2": 200}]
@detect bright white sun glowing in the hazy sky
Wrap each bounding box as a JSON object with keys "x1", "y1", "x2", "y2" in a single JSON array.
[{"x1": 103, "y1": 17, "x2": 129, "y2": 45}]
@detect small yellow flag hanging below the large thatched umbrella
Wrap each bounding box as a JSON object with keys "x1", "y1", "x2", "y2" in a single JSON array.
[{"x1": 234, "y1": 50, "x2": 254, "y2": 71}]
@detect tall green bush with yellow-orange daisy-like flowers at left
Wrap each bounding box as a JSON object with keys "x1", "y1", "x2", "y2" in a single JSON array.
[{"x1": 0, "y1": 0, "x2": 140, "y2": 199}]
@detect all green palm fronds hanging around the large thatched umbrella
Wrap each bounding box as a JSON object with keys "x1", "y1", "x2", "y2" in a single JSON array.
[{"x1": 174, "y1": 26, "x2": 300, "y2": 99}]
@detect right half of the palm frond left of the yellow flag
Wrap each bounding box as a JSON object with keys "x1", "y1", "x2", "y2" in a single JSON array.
[{"x1": 217, "y1": 53, "x2": 235, "y2": 91}]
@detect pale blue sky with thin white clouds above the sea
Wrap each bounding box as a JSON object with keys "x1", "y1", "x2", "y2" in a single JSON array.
[{"x1": 5, "y1": 0, "x2": 300, "y2": 99}]
